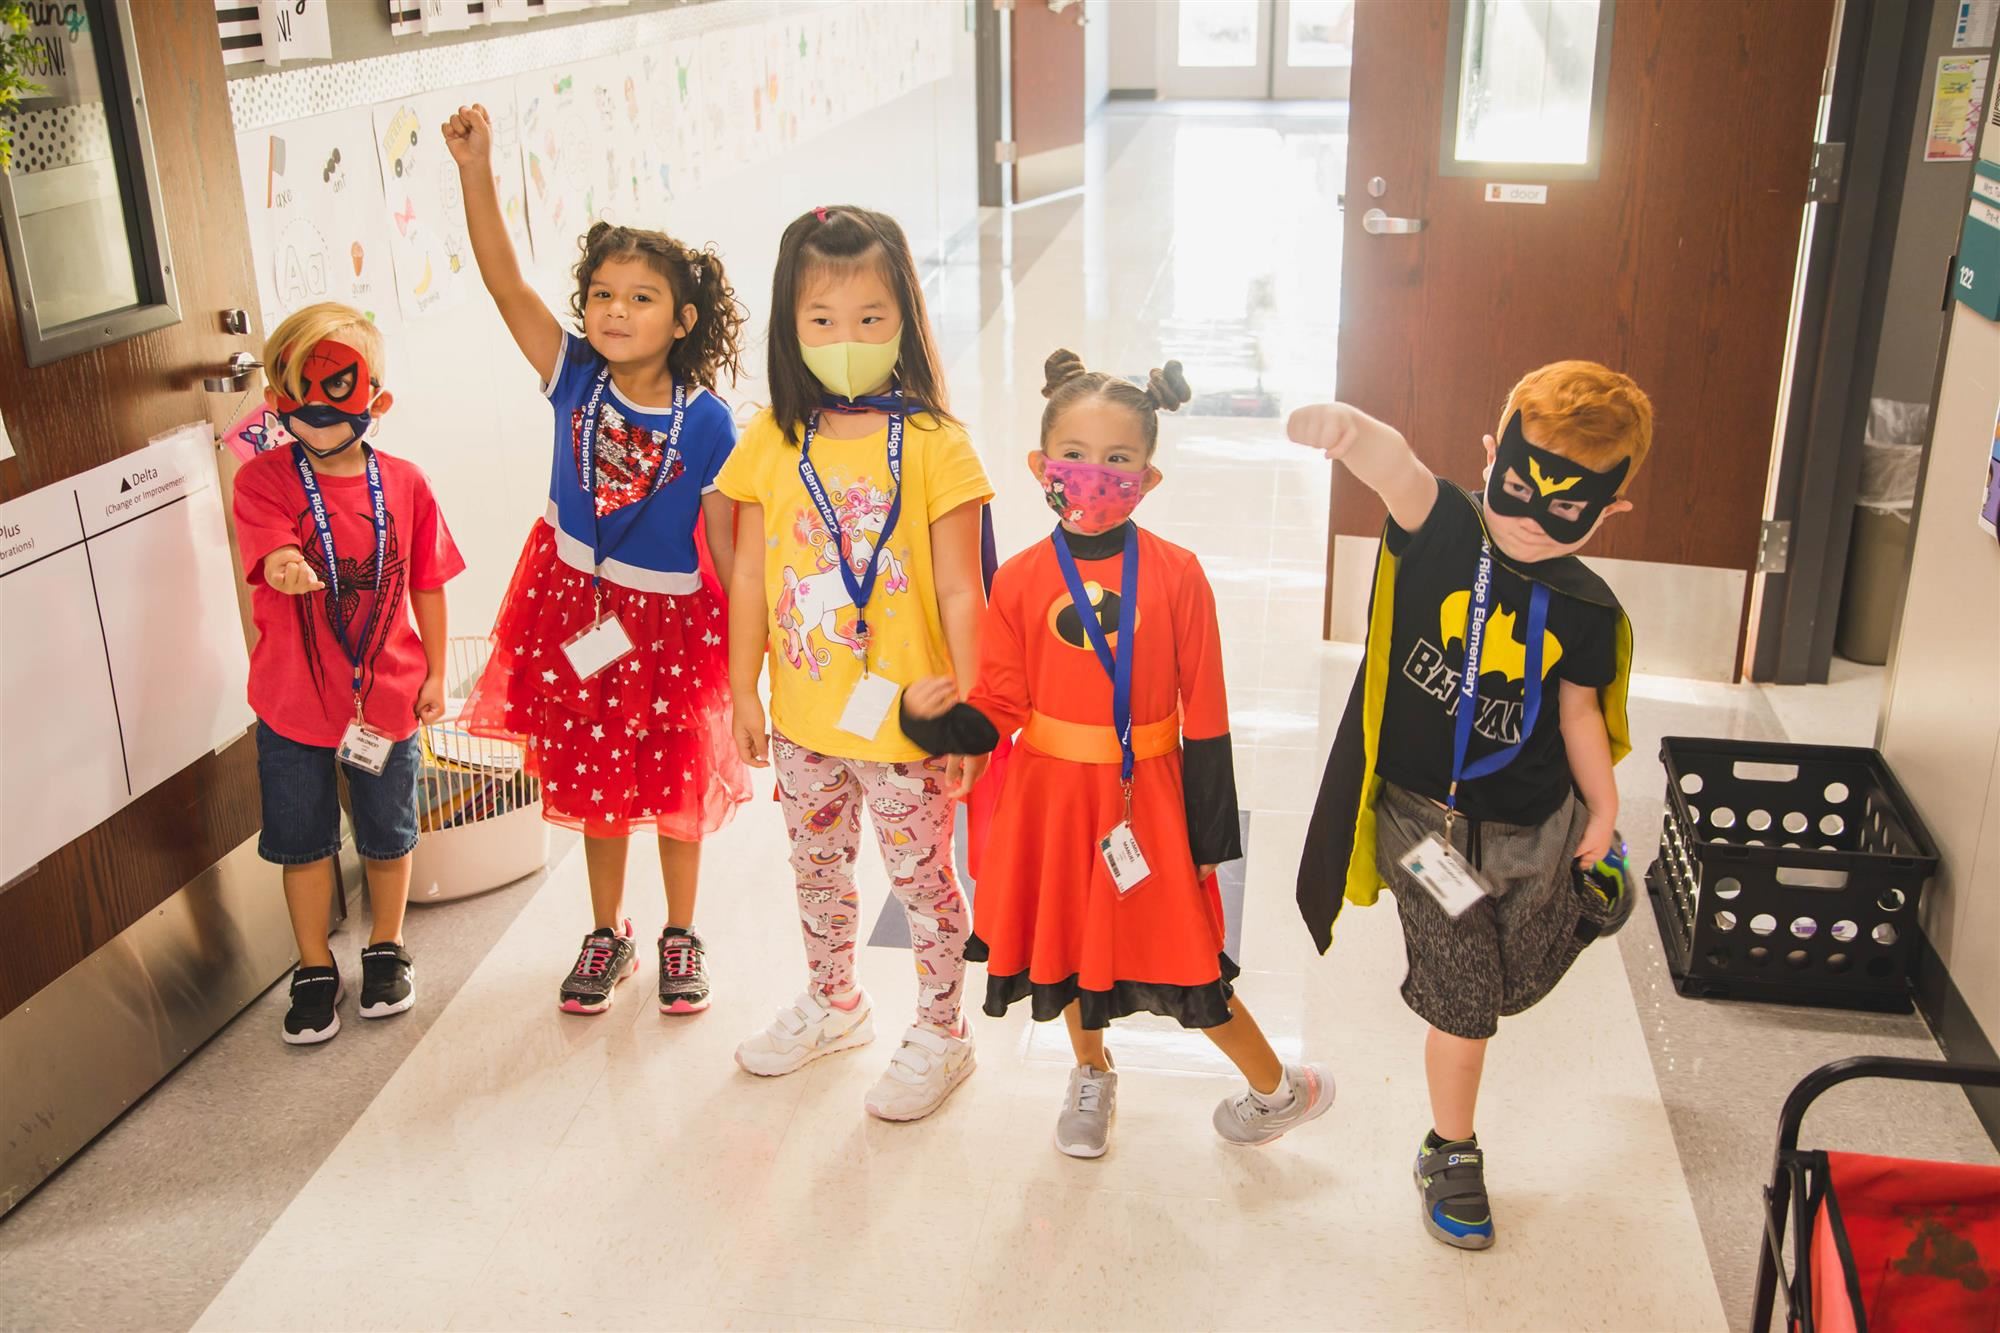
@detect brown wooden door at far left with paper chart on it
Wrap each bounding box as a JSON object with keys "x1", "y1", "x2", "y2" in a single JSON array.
[{"x1": 0, "y1": 0, "x2": 276, "y2": 1015}]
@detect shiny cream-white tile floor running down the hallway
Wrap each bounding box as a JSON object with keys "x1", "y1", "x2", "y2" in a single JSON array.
[{"x1": 198, "y1": 106, "x2": 1724, "y2": 1329}]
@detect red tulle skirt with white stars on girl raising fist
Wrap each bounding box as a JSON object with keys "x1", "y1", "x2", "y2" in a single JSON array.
[{"x1": 460, "y1": 520, "x2": 750, "y2": 843}]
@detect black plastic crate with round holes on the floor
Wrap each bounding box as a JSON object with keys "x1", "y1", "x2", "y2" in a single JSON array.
[{"x1": 1646, "y1": 737, "x2": 1938, "y2": 1013}]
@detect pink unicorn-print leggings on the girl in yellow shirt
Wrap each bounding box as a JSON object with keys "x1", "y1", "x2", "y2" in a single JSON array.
[{"x1": 770, "y1": 735, "x2": 968, "y2": 1027}]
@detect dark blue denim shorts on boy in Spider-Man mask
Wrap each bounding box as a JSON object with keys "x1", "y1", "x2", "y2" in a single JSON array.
[{"x1": 256, "y1": 723, "x2": 420, "y2": 865}]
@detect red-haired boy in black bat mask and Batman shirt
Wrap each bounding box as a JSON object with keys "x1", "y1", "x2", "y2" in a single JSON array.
[{"x1": 1290, "y1": 360, "x2": 1652, "y2": 1249}]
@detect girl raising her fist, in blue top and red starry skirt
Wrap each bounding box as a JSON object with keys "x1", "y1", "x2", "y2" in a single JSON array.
[{"x1": 444, "y1": 106, "x2": 750, "y2": 1015}]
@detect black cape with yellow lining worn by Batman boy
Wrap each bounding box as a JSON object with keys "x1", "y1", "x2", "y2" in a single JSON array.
[{"x1": 1298, "y1": 488, "x2": 1632, "y2": 953}]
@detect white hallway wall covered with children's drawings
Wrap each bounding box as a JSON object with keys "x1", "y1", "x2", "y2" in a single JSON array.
[{"x1": 230, "y1": 0, "x2": 978, "y2": 632}]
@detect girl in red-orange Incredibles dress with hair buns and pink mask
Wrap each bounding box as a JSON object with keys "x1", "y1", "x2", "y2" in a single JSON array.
[{"x1": 902, "y1": 350, "x2": 1334, "y2": 1157}]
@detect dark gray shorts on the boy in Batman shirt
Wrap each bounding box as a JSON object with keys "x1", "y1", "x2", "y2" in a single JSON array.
[{"x1": 1376, "y1": 783, "x2": 1602, "y2": 1039}]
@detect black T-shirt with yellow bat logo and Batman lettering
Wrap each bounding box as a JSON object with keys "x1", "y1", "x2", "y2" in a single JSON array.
[{"x1": 1376, "y1": 480, "x2": 1618, "y2": 825}]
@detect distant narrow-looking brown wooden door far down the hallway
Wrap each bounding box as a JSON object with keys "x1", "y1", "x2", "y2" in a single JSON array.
[{"x1": 1008, "y1": 0, "x2": 1084, "y2": 204}]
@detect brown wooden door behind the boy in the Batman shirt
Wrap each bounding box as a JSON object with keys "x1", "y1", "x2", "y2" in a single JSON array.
[{"x1": 1330, "y1": 0, "x2": 1834, "y2": 582}]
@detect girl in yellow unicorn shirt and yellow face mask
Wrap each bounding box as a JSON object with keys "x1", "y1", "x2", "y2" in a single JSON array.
[{"x1": 716, "y1": 208, "x2": 992, "y2": 1121}]
